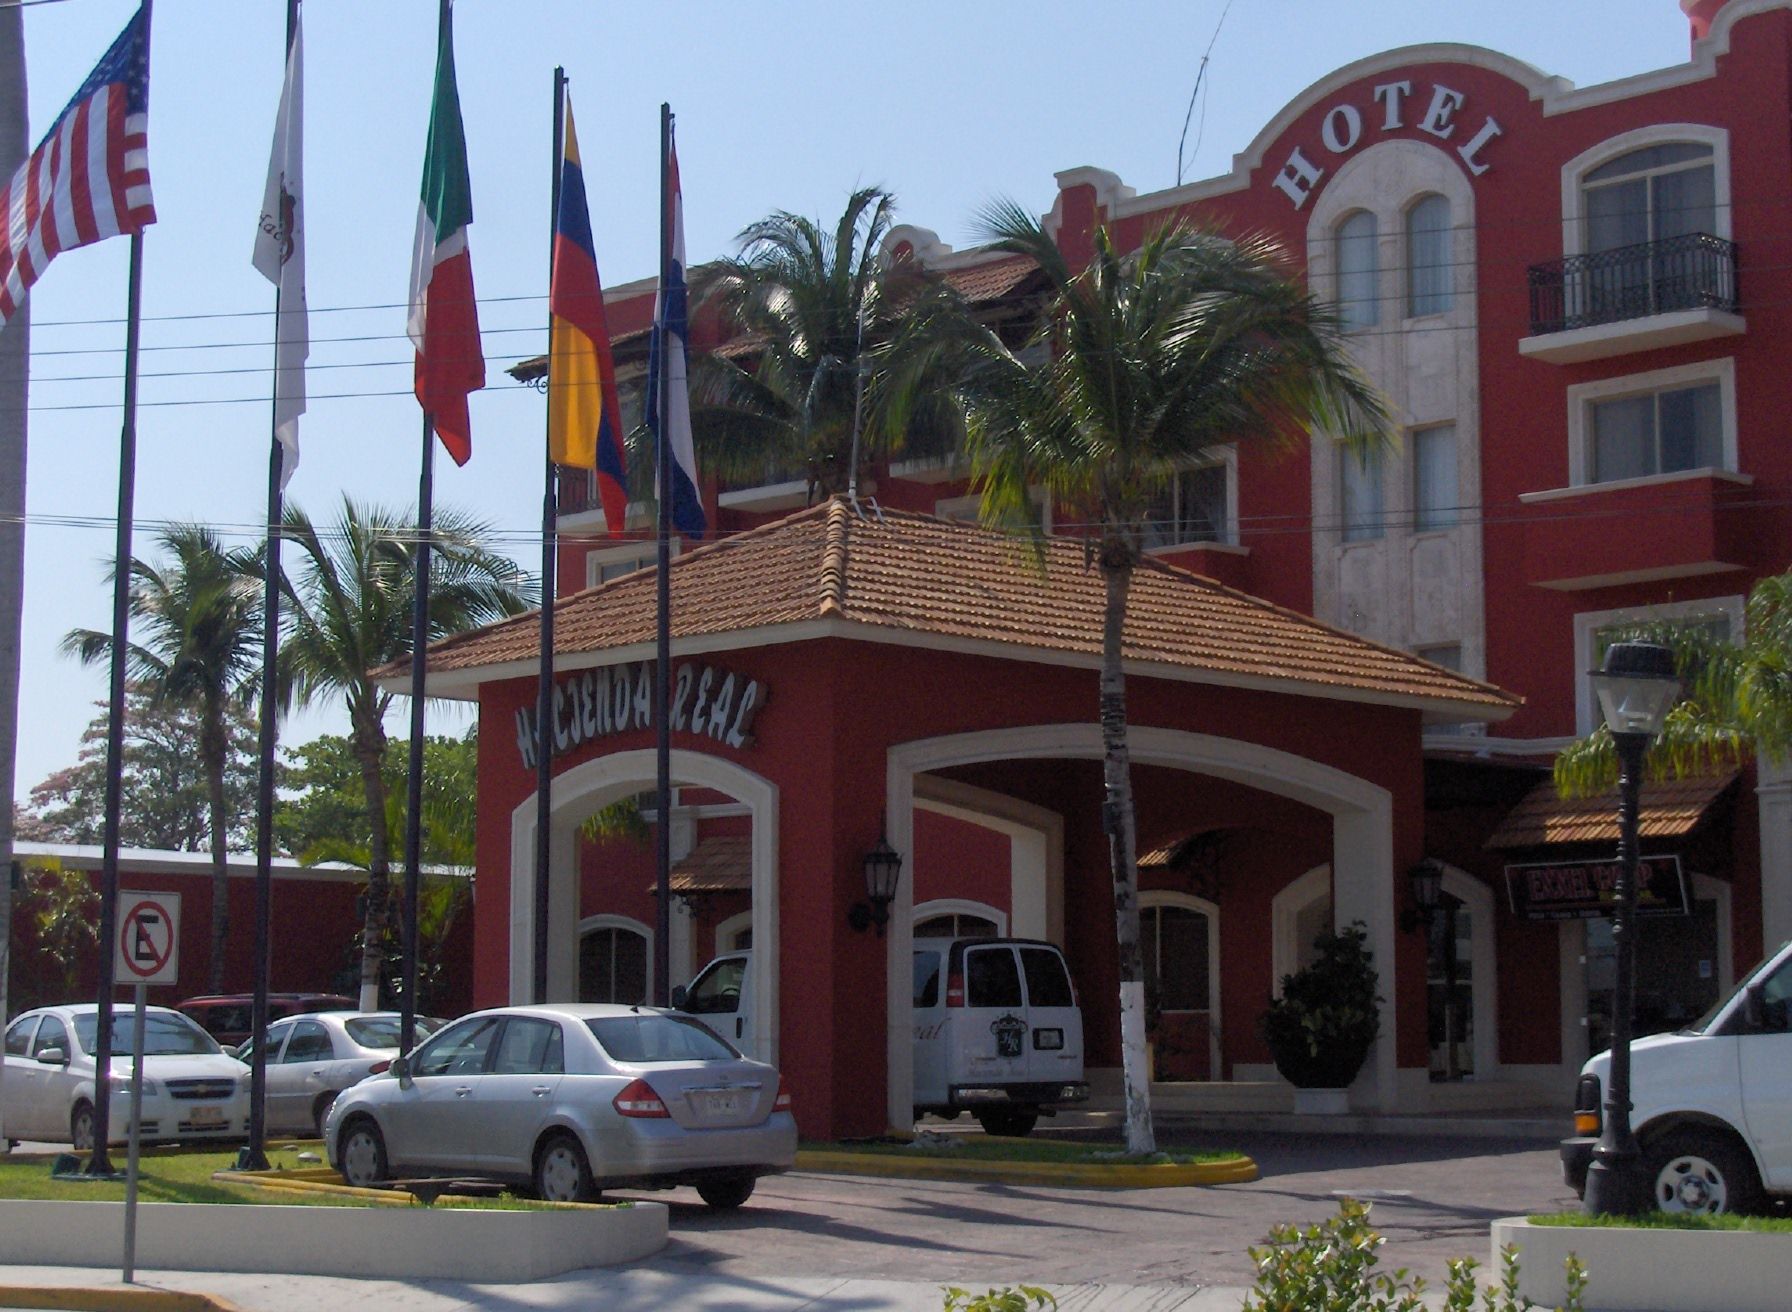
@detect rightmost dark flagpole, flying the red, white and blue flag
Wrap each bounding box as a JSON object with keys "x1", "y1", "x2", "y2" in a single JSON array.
[{"x1": 654, "y1": 104, "x2": 672, "y2": 1007}]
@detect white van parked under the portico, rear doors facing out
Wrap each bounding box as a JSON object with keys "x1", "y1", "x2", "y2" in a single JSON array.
[{"x1": 672, "y1": 939, "x2": 1090, "y2": 1135}]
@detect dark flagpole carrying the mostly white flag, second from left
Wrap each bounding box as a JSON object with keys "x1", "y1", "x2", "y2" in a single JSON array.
[{"x1": 238, "y1": 0, "x2": 299, "y2": 1170}]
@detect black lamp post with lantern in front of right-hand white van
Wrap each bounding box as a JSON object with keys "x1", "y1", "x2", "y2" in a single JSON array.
[{"x1": 1586, "y1": 642, "x2": 1679, "y2": 1217}]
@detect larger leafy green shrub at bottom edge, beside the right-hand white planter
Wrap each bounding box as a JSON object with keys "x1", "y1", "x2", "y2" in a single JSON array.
[{"x1": 1244, "y1": 1197, "x2": 1586, "y2": 1312}]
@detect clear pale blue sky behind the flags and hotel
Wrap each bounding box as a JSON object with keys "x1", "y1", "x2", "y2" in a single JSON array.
[{"x1": 16, "y1": 0, "x2": 1688, "y2": 799}]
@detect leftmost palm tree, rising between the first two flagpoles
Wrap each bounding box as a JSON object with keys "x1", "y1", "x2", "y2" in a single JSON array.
[{"x1": 63, "y1": 523, "x2": 262, "y2": 993}]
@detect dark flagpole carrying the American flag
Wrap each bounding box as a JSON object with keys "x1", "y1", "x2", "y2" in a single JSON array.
[{"x1": 88, "y1": 0, "x2": 151, "y2": 1176}]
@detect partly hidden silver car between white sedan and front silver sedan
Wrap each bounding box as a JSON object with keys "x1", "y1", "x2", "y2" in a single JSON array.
[{"x1": 237, "y1": 1011, "x2": 443, "y2": 1138}]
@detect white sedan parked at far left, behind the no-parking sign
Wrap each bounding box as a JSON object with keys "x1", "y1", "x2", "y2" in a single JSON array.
[{"x1": 4, "y1": 1002, "x2": 249, "y2": 1152}]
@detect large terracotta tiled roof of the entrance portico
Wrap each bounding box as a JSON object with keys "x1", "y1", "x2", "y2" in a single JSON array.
[{"x1": 388, "y1": 498, "x2": 1521, "y2": 721}]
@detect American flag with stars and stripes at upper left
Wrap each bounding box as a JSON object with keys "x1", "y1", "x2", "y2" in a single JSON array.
[{"x1": 0, "y1": 9, "x2": 156, "y2": 328}]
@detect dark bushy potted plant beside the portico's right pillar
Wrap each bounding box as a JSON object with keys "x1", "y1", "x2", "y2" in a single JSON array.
[{"x1": 1260, "y1": 921, "x2": 1382, "y2": 1111}]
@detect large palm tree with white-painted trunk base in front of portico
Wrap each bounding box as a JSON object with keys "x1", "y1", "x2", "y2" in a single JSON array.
[{"x1": 924, "y1": 203, "x2": 1389, "y2": 1152}]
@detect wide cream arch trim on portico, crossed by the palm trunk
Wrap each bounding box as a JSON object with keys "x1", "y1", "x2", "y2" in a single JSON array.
[{"x1": 885, "y1": 722, "x2": 1401, "y2": 1126}]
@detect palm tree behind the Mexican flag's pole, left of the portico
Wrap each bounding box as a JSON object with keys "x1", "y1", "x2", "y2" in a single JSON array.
[{"x1": 280, "y1": 498, "x2": 532, "y2": 1009}]
